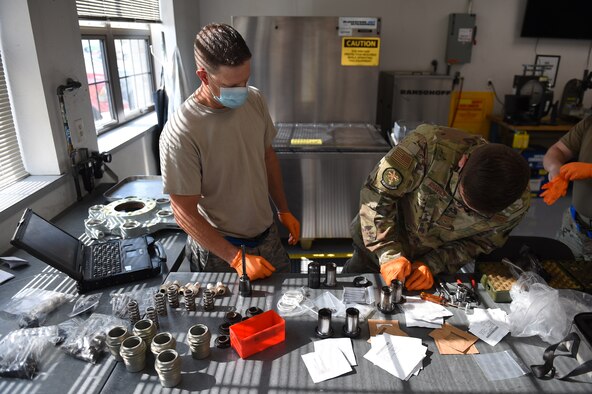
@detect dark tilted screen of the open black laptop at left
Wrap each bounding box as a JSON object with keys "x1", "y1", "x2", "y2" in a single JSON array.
[{"x1": 15, "y1": 210, "x2": 80, "y2": 277}]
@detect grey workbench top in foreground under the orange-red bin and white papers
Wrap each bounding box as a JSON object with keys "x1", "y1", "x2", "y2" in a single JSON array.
[{"x1": 0, "y1": 272, "x2": 592, "y2": 394}]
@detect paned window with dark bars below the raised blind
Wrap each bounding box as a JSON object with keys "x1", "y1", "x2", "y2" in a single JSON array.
[{"x1": 81, "y1": 23, "x2": 154, "y2": 134}]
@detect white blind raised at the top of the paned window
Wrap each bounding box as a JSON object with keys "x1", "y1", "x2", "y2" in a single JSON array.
[{"x1": 76, "y1": 0, "x2": 160, "y2": 22}]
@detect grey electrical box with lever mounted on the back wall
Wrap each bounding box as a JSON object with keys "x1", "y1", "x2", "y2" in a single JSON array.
[{"x1": 446, "y1": 14, "x2": 476, "y2": 64}]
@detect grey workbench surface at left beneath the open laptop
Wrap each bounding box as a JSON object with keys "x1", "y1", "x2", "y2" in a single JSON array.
[{"x1": 0, "y1": 185, "x2": 186, "y2": 394}]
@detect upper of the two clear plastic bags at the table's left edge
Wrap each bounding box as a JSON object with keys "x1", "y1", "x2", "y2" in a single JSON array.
[{"x1": 2, "y1": 289, "x2": 74, "y2": 328}]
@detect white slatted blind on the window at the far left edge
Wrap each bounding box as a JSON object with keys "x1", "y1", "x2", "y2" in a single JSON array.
[{"x1": 0, "y1": 52, "x2": 29, "y2": 190}]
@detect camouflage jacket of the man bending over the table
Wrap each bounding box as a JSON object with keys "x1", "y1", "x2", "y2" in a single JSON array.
[{"x1": 352, "y1": 125, "x2": 530, "y2": 274}]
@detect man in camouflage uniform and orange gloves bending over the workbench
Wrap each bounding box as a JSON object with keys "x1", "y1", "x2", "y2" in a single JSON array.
[{"x1": 343, "y1": 125, "x2": 530, "y2": 290}]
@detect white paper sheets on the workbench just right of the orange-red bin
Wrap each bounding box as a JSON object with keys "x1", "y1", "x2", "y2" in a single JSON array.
[{"x1": 302, "y1": 348, "x2": 352, "y2": 383}]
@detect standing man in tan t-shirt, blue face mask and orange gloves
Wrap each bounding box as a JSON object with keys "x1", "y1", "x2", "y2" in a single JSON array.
[{"x1": 160, "y1": 24, "x2": 300, "y2": 280}]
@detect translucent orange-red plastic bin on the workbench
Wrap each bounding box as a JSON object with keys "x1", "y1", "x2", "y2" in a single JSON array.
[{"x1": 230, "y1": 310, "x2": 286, "y2": 358}]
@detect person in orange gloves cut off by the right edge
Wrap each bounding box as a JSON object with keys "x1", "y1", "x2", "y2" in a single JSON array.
[{"x1": 541, "y1": 116, "x2": 592, "y2": 261}]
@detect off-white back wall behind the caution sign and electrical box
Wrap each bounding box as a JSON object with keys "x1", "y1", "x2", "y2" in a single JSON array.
[{"x1": 199, "y1": 0, "x2": 592, "y2": 111}]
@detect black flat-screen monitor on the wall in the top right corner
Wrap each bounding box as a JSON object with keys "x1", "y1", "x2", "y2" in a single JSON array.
[{"x1": 520, "y1": 0, "x2": 592, "y2": 39}]
